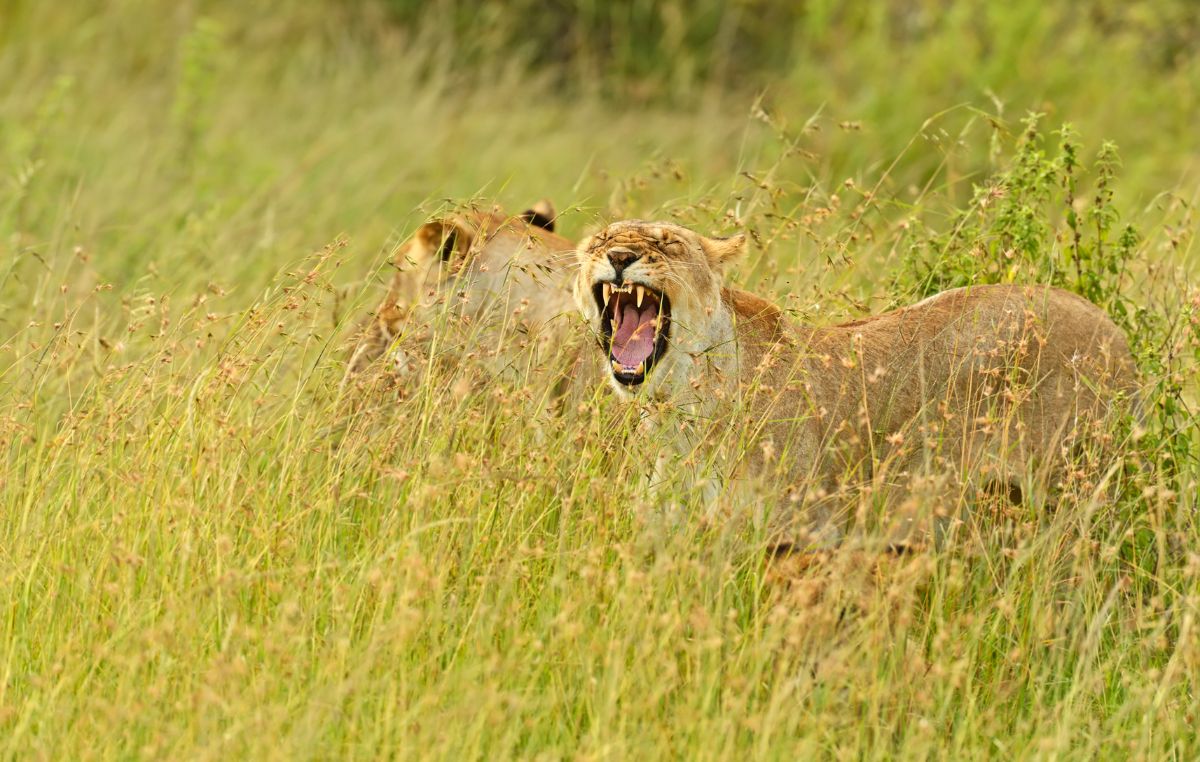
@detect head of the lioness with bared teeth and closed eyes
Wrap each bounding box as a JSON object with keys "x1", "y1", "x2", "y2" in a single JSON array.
[{"x1": 575, "y1": 220, "x2": 746, "y2": 394}]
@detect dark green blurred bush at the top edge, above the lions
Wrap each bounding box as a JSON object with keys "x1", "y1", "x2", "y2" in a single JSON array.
[{"x1": 374, "y1": 0, "x2": 806, "y2": 98}]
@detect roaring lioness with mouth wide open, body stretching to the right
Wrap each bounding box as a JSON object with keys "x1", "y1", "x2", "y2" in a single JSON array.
[{"x1": 575, "y1": 220, "x2": 1134, "y2": 545}]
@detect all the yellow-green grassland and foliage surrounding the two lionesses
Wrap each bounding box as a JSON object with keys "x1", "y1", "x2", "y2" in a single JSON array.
[{"x1": 0, "y1": 0, "x2": 1200, "y2": 760}]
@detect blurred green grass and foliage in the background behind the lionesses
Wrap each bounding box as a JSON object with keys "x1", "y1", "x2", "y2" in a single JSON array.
[{"x1": 0, "y1": 0, "x2": 1200, "y2": 309}]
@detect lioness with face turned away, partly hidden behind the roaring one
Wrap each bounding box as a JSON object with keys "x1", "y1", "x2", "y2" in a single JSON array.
[{"x1": 347, "y1": 200, "x2": 575, "y2": 378}]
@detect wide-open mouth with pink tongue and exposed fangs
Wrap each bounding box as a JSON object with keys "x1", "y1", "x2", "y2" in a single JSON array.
[{"x1": 592, "y1": 282, "x2": 671, "y2": 386}]
